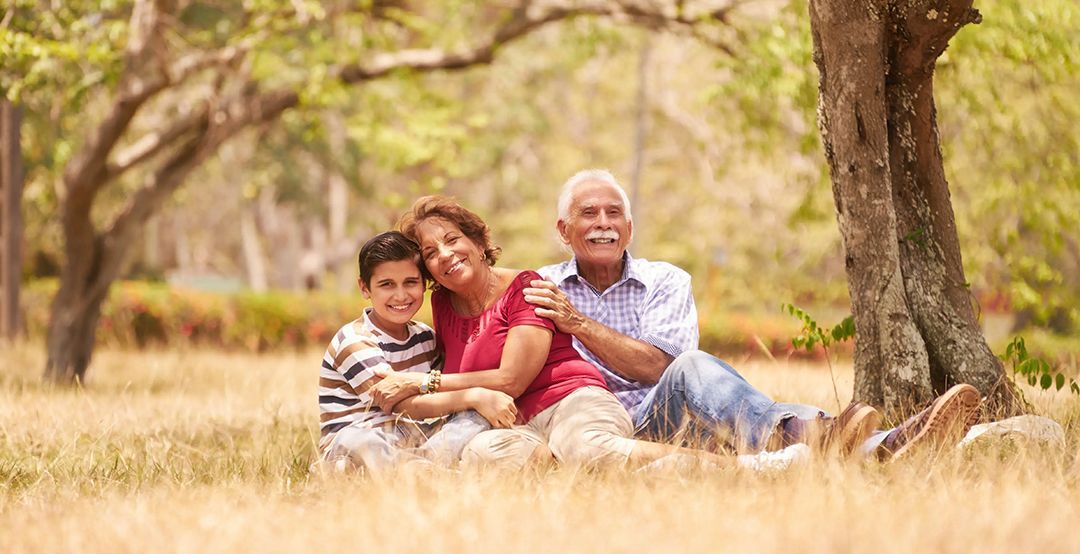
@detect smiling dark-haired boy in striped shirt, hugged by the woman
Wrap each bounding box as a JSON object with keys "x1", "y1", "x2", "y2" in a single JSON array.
[{"x1": 319, "y1": 231, "x2": 517, "y2": 471}]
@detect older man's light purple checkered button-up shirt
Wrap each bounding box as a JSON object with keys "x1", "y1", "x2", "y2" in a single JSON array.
[{"x1": 539, "y1": 253, "x2": 698, "y2": 415}]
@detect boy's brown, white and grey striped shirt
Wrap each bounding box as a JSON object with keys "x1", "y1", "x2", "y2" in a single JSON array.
[{"x1": 319, "y1": 308, "x2": 441, "y2": 450}]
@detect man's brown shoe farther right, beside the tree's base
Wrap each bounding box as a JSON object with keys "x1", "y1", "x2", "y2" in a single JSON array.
[{"x1": 878, "y1": 384, "x2": 982, "y2": 460}]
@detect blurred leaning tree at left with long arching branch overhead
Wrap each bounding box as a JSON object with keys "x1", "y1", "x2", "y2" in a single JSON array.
[{"x1": 2, "y1": 0, "x2": 734, "y2": 382}]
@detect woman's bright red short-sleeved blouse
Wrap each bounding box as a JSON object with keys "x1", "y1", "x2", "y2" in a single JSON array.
[{"x1": 431, "y1": 271, "x2": 607, "y2": 423}]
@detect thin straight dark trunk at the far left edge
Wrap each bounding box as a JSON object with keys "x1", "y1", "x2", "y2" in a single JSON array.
[{"x1": 0, "y1": 100, "x2": 23, "y2": 339}]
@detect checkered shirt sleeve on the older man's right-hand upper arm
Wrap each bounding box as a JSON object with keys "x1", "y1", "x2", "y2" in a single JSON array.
[{"x1": 638, "y1": 267, "x2": 698, "y2": 357}]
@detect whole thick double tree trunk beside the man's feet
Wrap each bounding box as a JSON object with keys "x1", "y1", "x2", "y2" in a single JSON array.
[{"x1": 810, "y1": 0, "x2": 1013, "y2": 414}]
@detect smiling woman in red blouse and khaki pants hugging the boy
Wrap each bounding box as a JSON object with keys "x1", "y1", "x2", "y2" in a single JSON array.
[{"x1": 373, "y1": 197, "x2": 803, "y2": 467}]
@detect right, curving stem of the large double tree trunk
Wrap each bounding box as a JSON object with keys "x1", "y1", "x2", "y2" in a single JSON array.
[{"x1": 887, "y1": 0, "x2": 1014, "y2": 414}]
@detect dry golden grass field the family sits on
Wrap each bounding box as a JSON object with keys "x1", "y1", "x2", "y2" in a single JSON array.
[{"x1": 0, "y1": 344, "x2": 1080, "y2": 554}]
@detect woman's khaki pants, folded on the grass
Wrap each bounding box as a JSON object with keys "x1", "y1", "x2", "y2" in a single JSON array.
[{"x1": 461, "y1": 387, "x2": 636, "y2": 469}]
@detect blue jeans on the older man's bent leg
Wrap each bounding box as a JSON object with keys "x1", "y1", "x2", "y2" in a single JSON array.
[{"x1": 633, "y1": 350, "x2": 851, "y2": 452}]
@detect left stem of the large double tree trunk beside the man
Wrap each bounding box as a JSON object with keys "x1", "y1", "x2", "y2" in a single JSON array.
[{"x1": 810, "y1": 1, "x2": 930, "y2": 411}]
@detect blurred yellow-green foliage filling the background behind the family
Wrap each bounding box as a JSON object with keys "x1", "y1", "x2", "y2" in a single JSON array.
[{"x1": 0, "y1": 0, "x2": 1080, "y2": 353}]
